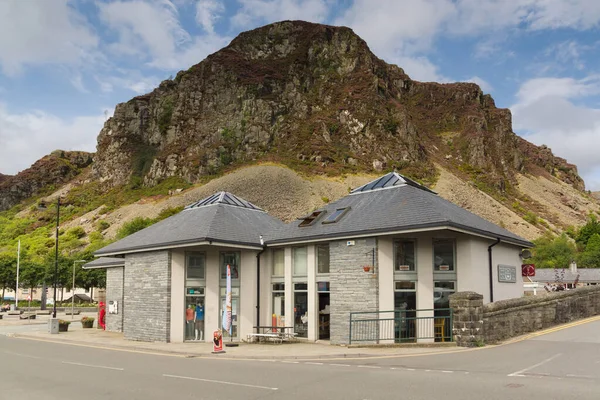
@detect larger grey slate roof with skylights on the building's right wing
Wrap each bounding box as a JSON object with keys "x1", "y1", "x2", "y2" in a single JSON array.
[{"x1": 265, "y1": 173, "x2": 533, "y2": 247}]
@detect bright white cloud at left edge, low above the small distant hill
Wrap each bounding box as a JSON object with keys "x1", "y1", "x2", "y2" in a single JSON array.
[{"x1": 0, "y1": 103, "x2": 113, "y2": 175}]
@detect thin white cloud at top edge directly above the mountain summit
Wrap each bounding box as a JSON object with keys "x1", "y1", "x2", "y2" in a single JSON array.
[{"x1": 231, "y1": 0, "x2": 329, "y2": 28}]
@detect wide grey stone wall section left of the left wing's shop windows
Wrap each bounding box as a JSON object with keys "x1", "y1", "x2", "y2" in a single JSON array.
[{"x1": 123, "y1": 250, "x2": 171, "y2": 342}]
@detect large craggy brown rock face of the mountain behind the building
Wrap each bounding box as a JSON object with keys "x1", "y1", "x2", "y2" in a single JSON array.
[{"x1": 93, "y1": 21, "x2": 582, "y2": 190}]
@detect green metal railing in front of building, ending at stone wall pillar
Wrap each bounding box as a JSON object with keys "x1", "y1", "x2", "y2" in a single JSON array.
[{"x1": 348, "y1": 308, "x2": 454, "y2": 344}]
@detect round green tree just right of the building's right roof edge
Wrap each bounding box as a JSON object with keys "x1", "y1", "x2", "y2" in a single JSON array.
[{"x1": 531, "y1": 233, "x2": 577, "y2": 268}]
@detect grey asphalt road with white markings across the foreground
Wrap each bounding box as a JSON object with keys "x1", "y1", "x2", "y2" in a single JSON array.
[{"x1": 0, "y1": 321, "x2": 600, "y2": 400}]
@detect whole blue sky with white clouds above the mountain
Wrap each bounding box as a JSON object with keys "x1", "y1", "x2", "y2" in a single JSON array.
[{"x1": 0, "y1": 0, "x2": 600, "y2": 190}]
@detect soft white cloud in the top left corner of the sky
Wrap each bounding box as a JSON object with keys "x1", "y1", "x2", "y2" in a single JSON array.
[{"x1": 0, "y1": 0, "x2": 98, "y2": 76}]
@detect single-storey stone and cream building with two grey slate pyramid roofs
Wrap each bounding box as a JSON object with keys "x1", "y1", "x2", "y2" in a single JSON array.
[{"x1": 84, "y1": 173, "x2": 532, "y2": 343}]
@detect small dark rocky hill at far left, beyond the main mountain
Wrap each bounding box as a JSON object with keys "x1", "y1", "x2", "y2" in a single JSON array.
[{"x1": 0, "y1": 150, "x2": 92, "y2": 211}]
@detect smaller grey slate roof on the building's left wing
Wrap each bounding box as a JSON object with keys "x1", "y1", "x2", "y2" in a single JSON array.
[{"x1": 95, "y1": 193, "x2": 284, "y2": 256}]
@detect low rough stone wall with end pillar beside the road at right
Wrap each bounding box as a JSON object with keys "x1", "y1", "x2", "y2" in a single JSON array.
[{"x1": 450, "y1": 286, "x2": 600, "y2": 347}]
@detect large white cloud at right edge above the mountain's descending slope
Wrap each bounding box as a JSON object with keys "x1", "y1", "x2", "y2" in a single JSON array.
[{"x1": 511, "y1": 76, "x2": 600, "y2": 190}]
